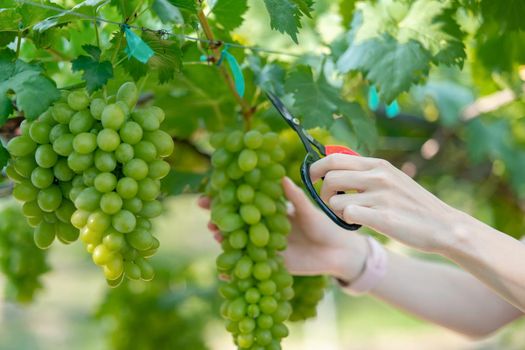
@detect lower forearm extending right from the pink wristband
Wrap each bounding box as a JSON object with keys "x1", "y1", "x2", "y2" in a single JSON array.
[{"x1": 370, "y1": 252, "x2": 521, "y2": 337}]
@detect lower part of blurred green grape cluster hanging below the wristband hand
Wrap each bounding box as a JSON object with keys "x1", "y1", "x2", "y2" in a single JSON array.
[{"x1": 290, "y1": 276, "x2": 328, "y2": 321}]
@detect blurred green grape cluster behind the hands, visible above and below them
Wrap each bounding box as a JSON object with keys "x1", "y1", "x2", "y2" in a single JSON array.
[{"x1": 279, "y1": 129, "x2": 335, "y2": 321}]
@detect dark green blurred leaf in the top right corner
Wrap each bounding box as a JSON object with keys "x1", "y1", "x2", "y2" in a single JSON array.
[{"x1": 481, "y1": 0, "x2": 525, "y2": 31}]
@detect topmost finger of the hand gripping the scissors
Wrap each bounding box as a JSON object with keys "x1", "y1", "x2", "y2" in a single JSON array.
[{"x1": 310, "y1": 153, "x2": 388, "y2": 182}]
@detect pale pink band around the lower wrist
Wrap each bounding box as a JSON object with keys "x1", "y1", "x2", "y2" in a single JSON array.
[{"x1": 337, "y1": 236, "x2": 388, "y2": 295}]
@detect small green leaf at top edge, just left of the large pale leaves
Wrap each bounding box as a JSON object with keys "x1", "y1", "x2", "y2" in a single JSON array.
[{"x1": 264, "y1": 0, "x2": 302, "y2": 43}]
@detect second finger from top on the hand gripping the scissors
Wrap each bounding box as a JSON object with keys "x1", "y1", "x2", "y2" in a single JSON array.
[{"x1": 320, "y1": 170, "x2": 369, "y2": 203}]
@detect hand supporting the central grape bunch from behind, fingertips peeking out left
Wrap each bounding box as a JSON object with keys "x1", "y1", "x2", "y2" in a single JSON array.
[{"x1": 195, "y1": 178, "x2": 368, "y2": 280}]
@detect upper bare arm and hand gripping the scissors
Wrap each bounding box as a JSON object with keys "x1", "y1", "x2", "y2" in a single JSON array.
[{"x1": 311, "y1": 155, "x2": 525, "y2": 311}]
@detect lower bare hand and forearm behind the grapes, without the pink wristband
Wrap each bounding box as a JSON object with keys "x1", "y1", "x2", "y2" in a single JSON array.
[{"x1": 278, "y1": 181, "x2": 522, "y2": 337}]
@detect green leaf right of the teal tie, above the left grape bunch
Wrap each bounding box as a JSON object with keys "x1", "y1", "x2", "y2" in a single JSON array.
[{"x1": 142, "y1": 32, "x2": 182, "y2": 84}]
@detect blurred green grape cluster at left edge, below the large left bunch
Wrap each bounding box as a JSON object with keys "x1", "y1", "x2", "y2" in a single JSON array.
[{"x1": 0, "y1": 204, "x2": 50, "y2": 303}]
